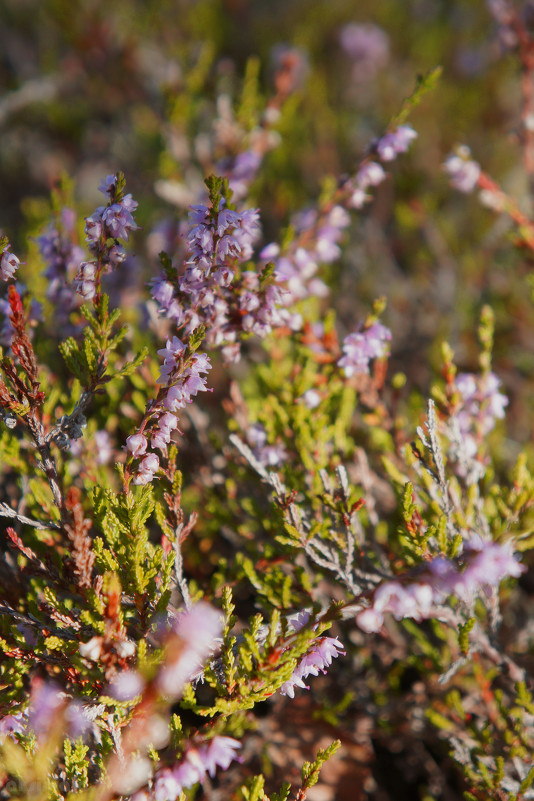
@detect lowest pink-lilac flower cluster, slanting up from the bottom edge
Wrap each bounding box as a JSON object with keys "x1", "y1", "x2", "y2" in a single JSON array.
[{"x1": 151, "y1": 735, "x2": 241, "y2": 801}]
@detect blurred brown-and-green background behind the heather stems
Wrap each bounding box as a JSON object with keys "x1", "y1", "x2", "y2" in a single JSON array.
[{"x1": 0, "y1": 0, "x2": 534, "y2": 450}]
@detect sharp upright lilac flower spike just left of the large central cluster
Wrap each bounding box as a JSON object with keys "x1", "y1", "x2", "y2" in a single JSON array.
[{"x1": 73, "y1": 173, "x2": 138, "y2": 300}]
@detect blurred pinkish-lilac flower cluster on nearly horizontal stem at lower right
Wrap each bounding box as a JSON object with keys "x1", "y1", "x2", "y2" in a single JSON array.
[{"x1": 356, "y1": 538, "x2": 526, "y2": 633}]
